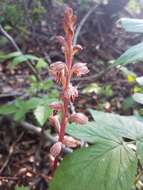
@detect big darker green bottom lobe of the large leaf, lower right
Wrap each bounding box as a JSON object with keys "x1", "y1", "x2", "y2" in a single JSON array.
[{"x1": 49, "y1": 138, "x2": 137, "y2": 190}]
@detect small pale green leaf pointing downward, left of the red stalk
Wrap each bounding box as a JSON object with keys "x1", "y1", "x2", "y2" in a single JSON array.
[{"x1": 34, "y1": 106, "x2": 51, "y2": 126}]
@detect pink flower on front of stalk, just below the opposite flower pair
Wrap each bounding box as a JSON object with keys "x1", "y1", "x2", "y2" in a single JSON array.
[{"x1": 64, "y1": 84, "x2": 78, "y2": 102}]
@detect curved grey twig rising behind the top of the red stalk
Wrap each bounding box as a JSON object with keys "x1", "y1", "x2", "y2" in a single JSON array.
[{"x1": 73, "y1": 5, "x2": 98, "y2": 45}]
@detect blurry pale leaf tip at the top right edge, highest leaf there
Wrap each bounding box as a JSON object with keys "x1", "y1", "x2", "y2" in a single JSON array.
[{"x1": 120, "y1": 18, "x2": 143, "y2": 33}]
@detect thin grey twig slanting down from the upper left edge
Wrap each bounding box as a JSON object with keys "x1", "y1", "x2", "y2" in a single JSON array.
[{"x1": 0, "y1": 24, "x2": 41, "y2": 80}]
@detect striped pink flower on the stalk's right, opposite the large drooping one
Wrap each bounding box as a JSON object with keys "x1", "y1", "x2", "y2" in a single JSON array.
[{"x1": 72, "y1": 62, "x2": 89, "y2": 77}]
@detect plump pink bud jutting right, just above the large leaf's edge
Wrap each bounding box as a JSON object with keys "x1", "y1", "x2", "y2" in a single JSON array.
[{"x1": 69, "y1": 113, "x2": 88, "y2": 124}]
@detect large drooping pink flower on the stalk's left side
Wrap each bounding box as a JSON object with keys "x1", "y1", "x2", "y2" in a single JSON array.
[{"x1": 49, "y1": 61, "x2": 67, "y2": 85}]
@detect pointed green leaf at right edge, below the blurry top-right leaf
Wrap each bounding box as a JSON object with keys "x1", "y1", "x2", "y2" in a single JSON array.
[{"x1": 114, "y1": 42, "x2": 143, "y2": 65}]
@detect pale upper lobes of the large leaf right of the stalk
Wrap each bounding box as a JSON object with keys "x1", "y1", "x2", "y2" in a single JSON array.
[{"x1": 66, "y1": 110, "x2": 143, "y2": 143}]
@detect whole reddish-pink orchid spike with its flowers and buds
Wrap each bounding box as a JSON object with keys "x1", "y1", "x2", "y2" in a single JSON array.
[{"x1": 49, "y1": 7, "x2": 89, "y2": 171}]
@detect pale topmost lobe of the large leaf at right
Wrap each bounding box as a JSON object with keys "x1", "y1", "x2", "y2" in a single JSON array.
[{"x1": 89, "y1": 109, "x2": 143, "y2": 140}]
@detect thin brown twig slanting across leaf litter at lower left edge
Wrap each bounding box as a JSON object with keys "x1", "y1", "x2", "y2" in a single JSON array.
[{"x1": 0, "y1": 132, "x2": 24, "y2": 174}]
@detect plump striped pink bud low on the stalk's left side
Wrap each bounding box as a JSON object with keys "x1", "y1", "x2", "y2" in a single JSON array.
[{"x1": 50, "y1": 142, "x2": 62, "y2": 158}]
